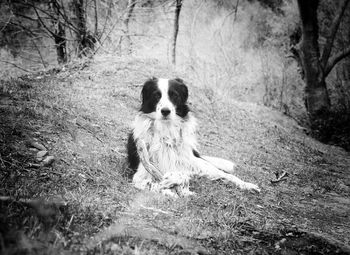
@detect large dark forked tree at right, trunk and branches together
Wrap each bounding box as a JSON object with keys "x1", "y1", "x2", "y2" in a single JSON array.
[{"x1": 293, "y1": 0, "x2": 350, "y2": 122}]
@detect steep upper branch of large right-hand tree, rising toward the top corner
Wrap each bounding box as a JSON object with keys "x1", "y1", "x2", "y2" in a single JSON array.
[{"x1": 321, "y1": 0, "x2": 350, "y2": 68}]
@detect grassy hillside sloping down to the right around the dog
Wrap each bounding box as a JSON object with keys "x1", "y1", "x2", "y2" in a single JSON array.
[{"x1": 0, "y1": 58, "x2": 350, "y2": 254}]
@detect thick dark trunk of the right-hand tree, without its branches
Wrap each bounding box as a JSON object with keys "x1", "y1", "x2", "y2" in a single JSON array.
[{"x1": 298, "y1": 0, "x2": 330, "y2": 121}]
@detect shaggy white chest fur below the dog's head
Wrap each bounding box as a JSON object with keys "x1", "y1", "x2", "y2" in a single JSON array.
[{"x1": 133, "y1": 114, "x2": 197, "y2": 177}]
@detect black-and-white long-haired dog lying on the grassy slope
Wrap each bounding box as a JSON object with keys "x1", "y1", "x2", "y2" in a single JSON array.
[{"x1": 128, "y1": 78, "x2": 260, "y2": 195}]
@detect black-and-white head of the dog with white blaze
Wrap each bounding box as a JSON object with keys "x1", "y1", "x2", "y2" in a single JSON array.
[{"x1": 141, "y1": 78, "x2": 189, "y2": 120}]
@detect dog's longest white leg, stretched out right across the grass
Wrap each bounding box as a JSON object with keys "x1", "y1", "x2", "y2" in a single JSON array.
[{"x1": 194, "y1": 157, "x2": 260, "y2": 192}]
